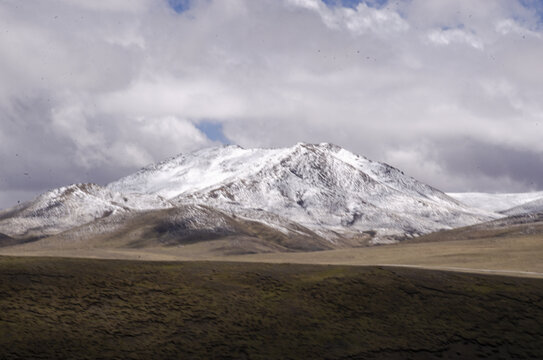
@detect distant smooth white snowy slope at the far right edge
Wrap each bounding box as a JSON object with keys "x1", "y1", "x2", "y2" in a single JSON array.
[{"x1": 447, "y1": 191, "x2": 543, "y2": 214}]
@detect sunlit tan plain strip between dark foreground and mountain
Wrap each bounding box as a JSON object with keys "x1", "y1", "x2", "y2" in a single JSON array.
[{"x1": 0, "y1": 235, "x2": 543, "y2": 277}]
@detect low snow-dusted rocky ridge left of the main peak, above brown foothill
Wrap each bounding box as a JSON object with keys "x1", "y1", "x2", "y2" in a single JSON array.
[{"x1": 0, "y1": 184, "x2": 172, "y2": 237}]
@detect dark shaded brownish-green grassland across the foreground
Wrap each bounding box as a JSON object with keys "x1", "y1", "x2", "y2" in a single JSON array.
[{"x1": 0, "y1": 257, "x2": 543, "y2": 359}]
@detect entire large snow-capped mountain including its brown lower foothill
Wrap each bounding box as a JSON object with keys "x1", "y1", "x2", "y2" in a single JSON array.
[{"x1": 0, "y1": 143, "x2": 500, "y2": 251}]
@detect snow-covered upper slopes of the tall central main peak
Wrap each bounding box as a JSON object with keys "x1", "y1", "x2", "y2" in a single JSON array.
[{"x1": 107, "y1": 143, "x2": 497, "y2": 241}]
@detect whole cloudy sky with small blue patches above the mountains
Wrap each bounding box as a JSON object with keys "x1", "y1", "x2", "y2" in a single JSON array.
[{"x1": 0, "y1": 0, "x2": 543, "y2": 208}]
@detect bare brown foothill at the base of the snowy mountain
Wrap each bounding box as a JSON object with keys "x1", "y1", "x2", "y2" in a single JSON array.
[{"x1": 9, "y1": 205, "x2": 332, "y2": 255}]
